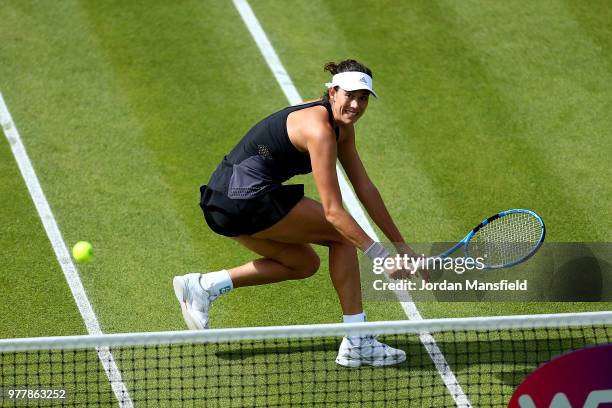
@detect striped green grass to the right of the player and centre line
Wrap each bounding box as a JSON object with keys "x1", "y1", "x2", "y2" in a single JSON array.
[{"x1": 249, "y1": 1, "x2": 612, "y2": 317}]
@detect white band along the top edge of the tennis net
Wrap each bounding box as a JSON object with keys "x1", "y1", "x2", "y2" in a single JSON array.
[{"x1": 0, "y1": 311, "x2": 612, "y2": 353}]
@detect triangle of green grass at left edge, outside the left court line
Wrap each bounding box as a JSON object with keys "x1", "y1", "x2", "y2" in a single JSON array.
[{"x1": 0, "y1": 125, "x2": 86, "y2": 337}]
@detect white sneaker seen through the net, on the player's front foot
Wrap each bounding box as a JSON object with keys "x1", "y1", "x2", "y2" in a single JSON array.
[{"x1": 336, "y1": 336, "x2": 406, "y2": 367}]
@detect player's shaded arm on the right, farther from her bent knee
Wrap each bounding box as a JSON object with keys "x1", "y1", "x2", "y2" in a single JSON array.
[{"x1": 338, "y1": 126, "x2": 418, "y2": 257}]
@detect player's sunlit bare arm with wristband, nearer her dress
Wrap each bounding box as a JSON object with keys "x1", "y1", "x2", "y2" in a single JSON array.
[{"x1": 306, "y1": 125, "x2": 373, "y2": 250}]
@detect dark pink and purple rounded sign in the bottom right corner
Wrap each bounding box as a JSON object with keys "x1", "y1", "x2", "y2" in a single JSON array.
[{"x1": 508, "y1": 344, "x2": 612, "y2": 408}]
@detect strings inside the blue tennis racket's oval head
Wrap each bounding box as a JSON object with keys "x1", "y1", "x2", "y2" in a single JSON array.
[{"x1": 468, "y1": 212, "x2": 542, "y2": 266}]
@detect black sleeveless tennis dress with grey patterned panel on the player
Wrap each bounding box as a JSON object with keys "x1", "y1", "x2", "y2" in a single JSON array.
[{"x1": 200, "y1": 101, "x2": 339, "y2": 237}]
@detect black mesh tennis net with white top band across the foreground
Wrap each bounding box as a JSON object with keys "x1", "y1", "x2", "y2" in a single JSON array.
[{"x1": 0, "y1": 312, "x2": 612, "y2": 407}]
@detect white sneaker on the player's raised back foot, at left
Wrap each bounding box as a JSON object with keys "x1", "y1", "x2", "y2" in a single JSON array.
[{"x1": 172, "y1": 273, "x2": 216, "y2": 330}]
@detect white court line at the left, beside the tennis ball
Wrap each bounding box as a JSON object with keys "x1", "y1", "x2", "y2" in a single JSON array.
[{"x1": 0, "y1": 93, "x2": 133, "y2": 408}]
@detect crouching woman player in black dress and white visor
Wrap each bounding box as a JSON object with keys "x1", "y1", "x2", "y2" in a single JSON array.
[{"x1": 173, "y1": 60, "x2": 413, "y2": 367}]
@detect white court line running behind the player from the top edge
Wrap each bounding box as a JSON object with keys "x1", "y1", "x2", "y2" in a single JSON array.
[{"x1": 233, "y1": 0, "x2": 472, "y2": 407}]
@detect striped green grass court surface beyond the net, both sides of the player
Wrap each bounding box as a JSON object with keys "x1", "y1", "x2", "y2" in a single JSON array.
[{"x1": 0, "y1": 0, "x2": 612, "y2": 404}]
